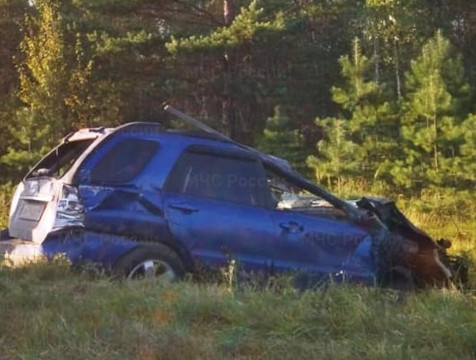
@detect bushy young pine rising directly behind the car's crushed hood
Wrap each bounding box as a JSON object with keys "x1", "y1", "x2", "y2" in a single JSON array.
[{"x1": 309, "y1": 39, "x2": 398, "y2": 190}]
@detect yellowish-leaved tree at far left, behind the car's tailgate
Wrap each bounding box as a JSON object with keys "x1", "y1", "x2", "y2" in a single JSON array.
[{"x1": 1, "y1": 0, "x2": 92, "y2": 179}]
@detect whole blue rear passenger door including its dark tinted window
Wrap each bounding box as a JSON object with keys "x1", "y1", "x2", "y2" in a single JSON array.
[{"x1": 164, "y1": 147, "x2": 274, "y2": 271}]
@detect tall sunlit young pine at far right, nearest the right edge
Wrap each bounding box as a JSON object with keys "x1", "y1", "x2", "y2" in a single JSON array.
[{"x1": 392, "y1": 31, "x2": 470, "y2": 189}]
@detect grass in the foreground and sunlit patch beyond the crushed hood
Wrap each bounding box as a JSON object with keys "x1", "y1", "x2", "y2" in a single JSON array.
[{"x1": 0, "y1": 187, "x2": 476, "y2": 360}]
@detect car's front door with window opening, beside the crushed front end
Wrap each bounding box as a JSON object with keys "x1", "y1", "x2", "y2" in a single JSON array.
[{"x1": 268, "y1": 172, "x2": 371, "y2": 279}]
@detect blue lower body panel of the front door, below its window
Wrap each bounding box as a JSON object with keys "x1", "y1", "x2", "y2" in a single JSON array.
[{"x1": 273, "y1": 210, "x2": 373, "y2": 277}]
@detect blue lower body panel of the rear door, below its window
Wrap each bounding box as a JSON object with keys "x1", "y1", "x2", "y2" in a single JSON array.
[{"x1": 165, "y1": 193, "x2": 273, "y2": 271}]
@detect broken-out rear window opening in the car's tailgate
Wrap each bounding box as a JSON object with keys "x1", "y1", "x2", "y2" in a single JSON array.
[{"x1": 27, "y1": 139, "x2": 94, "y2": 178}]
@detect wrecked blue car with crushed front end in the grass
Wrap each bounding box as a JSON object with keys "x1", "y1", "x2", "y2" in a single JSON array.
[{"x1": 0, "y1": 108, "x2": 465, "y2": 288}]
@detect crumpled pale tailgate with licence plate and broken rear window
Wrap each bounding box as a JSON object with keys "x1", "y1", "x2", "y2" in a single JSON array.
[{"x1": 9, "y1": 134, "x2": 99, "y2": 243}]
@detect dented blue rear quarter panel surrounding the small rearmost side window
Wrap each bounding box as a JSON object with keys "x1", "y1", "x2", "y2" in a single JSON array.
[{"x1": 74, "y1": 133, "x2": 180, "y2": 241}]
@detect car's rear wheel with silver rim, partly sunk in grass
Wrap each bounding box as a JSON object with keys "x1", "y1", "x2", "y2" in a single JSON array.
[{"x1": 113, "y1": 243, "x2": 185, "y2": 282}]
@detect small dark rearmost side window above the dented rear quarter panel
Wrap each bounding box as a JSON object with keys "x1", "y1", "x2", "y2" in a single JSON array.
[{"x1": 90, "y1": 139, "x2": 159, "y2": 184}]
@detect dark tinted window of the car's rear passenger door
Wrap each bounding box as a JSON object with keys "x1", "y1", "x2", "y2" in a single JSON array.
[{"x1": 166, "y1": 151, "x2": 267, "y2": 206}]
